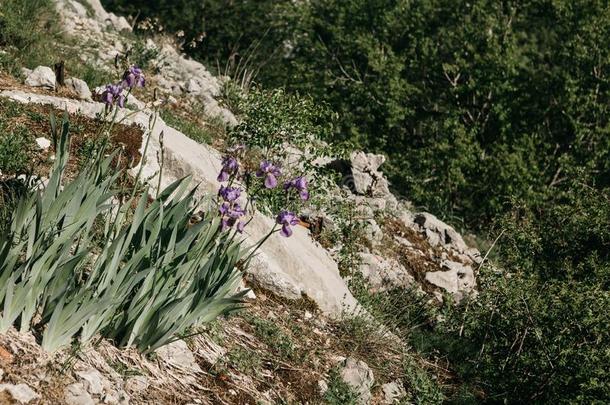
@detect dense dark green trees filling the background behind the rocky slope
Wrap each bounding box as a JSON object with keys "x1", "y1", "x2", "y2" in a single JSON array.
[{"x1": 109, "y1": 0, "x2": 610, "y2": 227}]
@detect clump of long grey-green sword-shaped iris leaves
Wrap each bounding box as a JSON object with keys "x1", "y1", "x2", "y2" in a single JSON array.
[{"x1": 0, "y1": 113, "x2": 248, "y2": 352}]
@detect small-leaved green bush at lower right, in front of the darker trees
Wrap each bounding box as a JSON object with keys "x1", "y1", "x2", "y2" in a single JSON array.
[{"x1": 440, "y1": 183, "x2": 610, "y2": 403}]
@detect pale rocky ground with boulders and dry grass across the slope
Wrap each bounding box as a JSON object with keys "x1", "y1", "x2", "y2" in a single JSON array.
[{"x1": 0, "y1": 0, "x2": 484, "y2": 404}]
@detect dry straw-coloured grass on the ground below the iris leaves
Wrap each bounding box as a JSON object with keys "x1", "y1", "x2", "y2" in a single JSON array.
[{"x1": 0, "y1": 280, "x2": 414, "y2": 405}]
